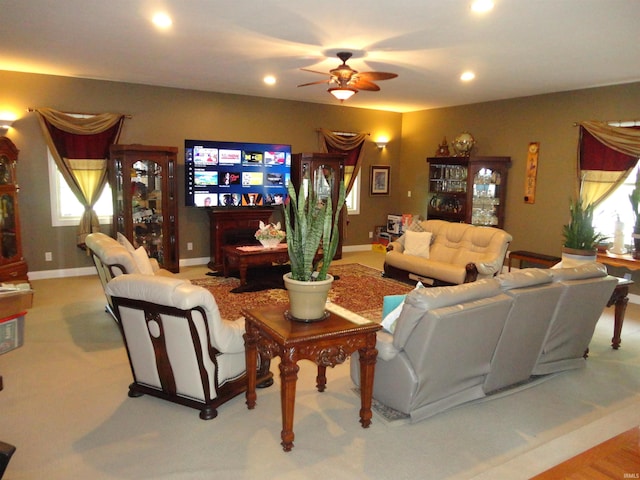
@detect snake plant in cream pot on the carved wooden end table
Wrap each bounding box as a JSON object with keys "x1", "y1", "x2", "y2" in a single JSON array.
[{"x1": 284, "y1": 176, "x2": 345, "y2": 322}]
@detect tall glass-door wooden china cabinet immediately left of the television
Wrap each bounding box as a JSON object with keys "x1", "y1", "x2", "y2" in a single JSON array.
[{"x1": 108, "y1": 145, "x2": 179, "y2": 272}]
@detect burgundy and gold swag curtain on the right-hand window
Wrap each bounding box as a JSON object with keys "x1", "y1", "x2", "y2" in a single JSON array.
[{"x1": 578, "y1": 121, "x2": 640, "y2": 205}]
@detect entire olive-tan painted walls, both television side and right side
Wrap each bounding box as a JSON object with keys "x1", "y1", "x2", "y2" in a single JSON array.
[{"x1": 0, "y1": 71, "x2": 640, "y2": 278}]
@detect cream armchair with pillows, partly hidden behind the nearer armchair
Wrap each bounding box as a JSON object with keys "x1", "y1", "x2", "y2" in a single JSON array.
[{"x1": 85, "y1": 232, "x2": 173, "y2": 318}]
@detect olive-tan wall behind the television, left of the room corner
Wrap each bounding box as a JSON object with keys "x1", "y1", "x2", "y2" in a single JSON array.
[{"x1": 0, "y1": 71, "x2": 402, "y2": 272}]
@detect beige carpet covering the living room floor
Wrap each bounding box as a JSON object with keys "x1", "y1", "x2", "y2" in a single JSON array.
[{"x1": 0, "y1": 253, "x2": 640, "y2": 480}]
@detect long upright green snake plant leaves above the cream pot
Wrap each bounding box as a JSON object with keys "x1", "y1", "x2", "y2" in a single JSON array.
[{"x1": 284, "y1": 182, "x2": 345, "y2": 282}]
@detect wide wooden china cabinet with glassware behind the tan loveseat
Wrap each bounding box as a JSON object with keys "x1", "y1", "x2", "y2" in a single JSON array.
[{"x1": 427, "y1": 157, "x2": 511, "y2": 228}]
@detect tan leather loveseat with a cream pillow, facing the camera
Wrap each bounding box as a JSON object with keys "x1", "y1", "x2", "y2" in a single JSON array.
[{"x1": 384, "y1": 220, "x2": 512, "y2": 286}]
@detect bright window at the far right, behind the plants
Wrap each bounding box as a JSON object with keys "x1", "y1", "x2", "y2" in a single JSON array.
[{"x1": 593, "y1": 164, "x2": 640, "y2": 248}]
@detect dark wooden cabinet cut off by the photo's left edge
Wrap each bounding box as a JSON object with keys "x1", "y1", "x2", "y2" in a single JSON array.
[{"x1": 0, "y1": 137, "x2": 28, "y2": 282}]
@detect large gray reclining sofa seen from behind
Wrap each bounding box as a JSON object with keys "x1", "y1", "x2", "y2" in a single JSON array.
[{"x1": 351, "y1": 263, "x2": 617, "y2": 422}]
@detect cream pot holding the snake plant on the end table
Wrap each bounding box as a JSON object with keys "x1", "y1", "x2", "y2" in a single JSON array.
[{"x1": 282, "y1": 273, "x2": 333, "y2": 322}]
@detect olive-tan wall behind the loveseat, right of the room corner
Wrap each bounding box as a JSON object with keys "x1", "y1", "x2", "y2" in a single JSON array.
[{"x1": 399, "y1": 83, "x2": 640, "y2": 256}]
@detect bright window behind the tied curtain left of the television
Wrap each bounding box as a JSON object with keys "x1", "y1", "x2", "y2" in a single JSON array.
[{"x1": 48, "y1": 152, "x2": 113, "y2": 227}]
